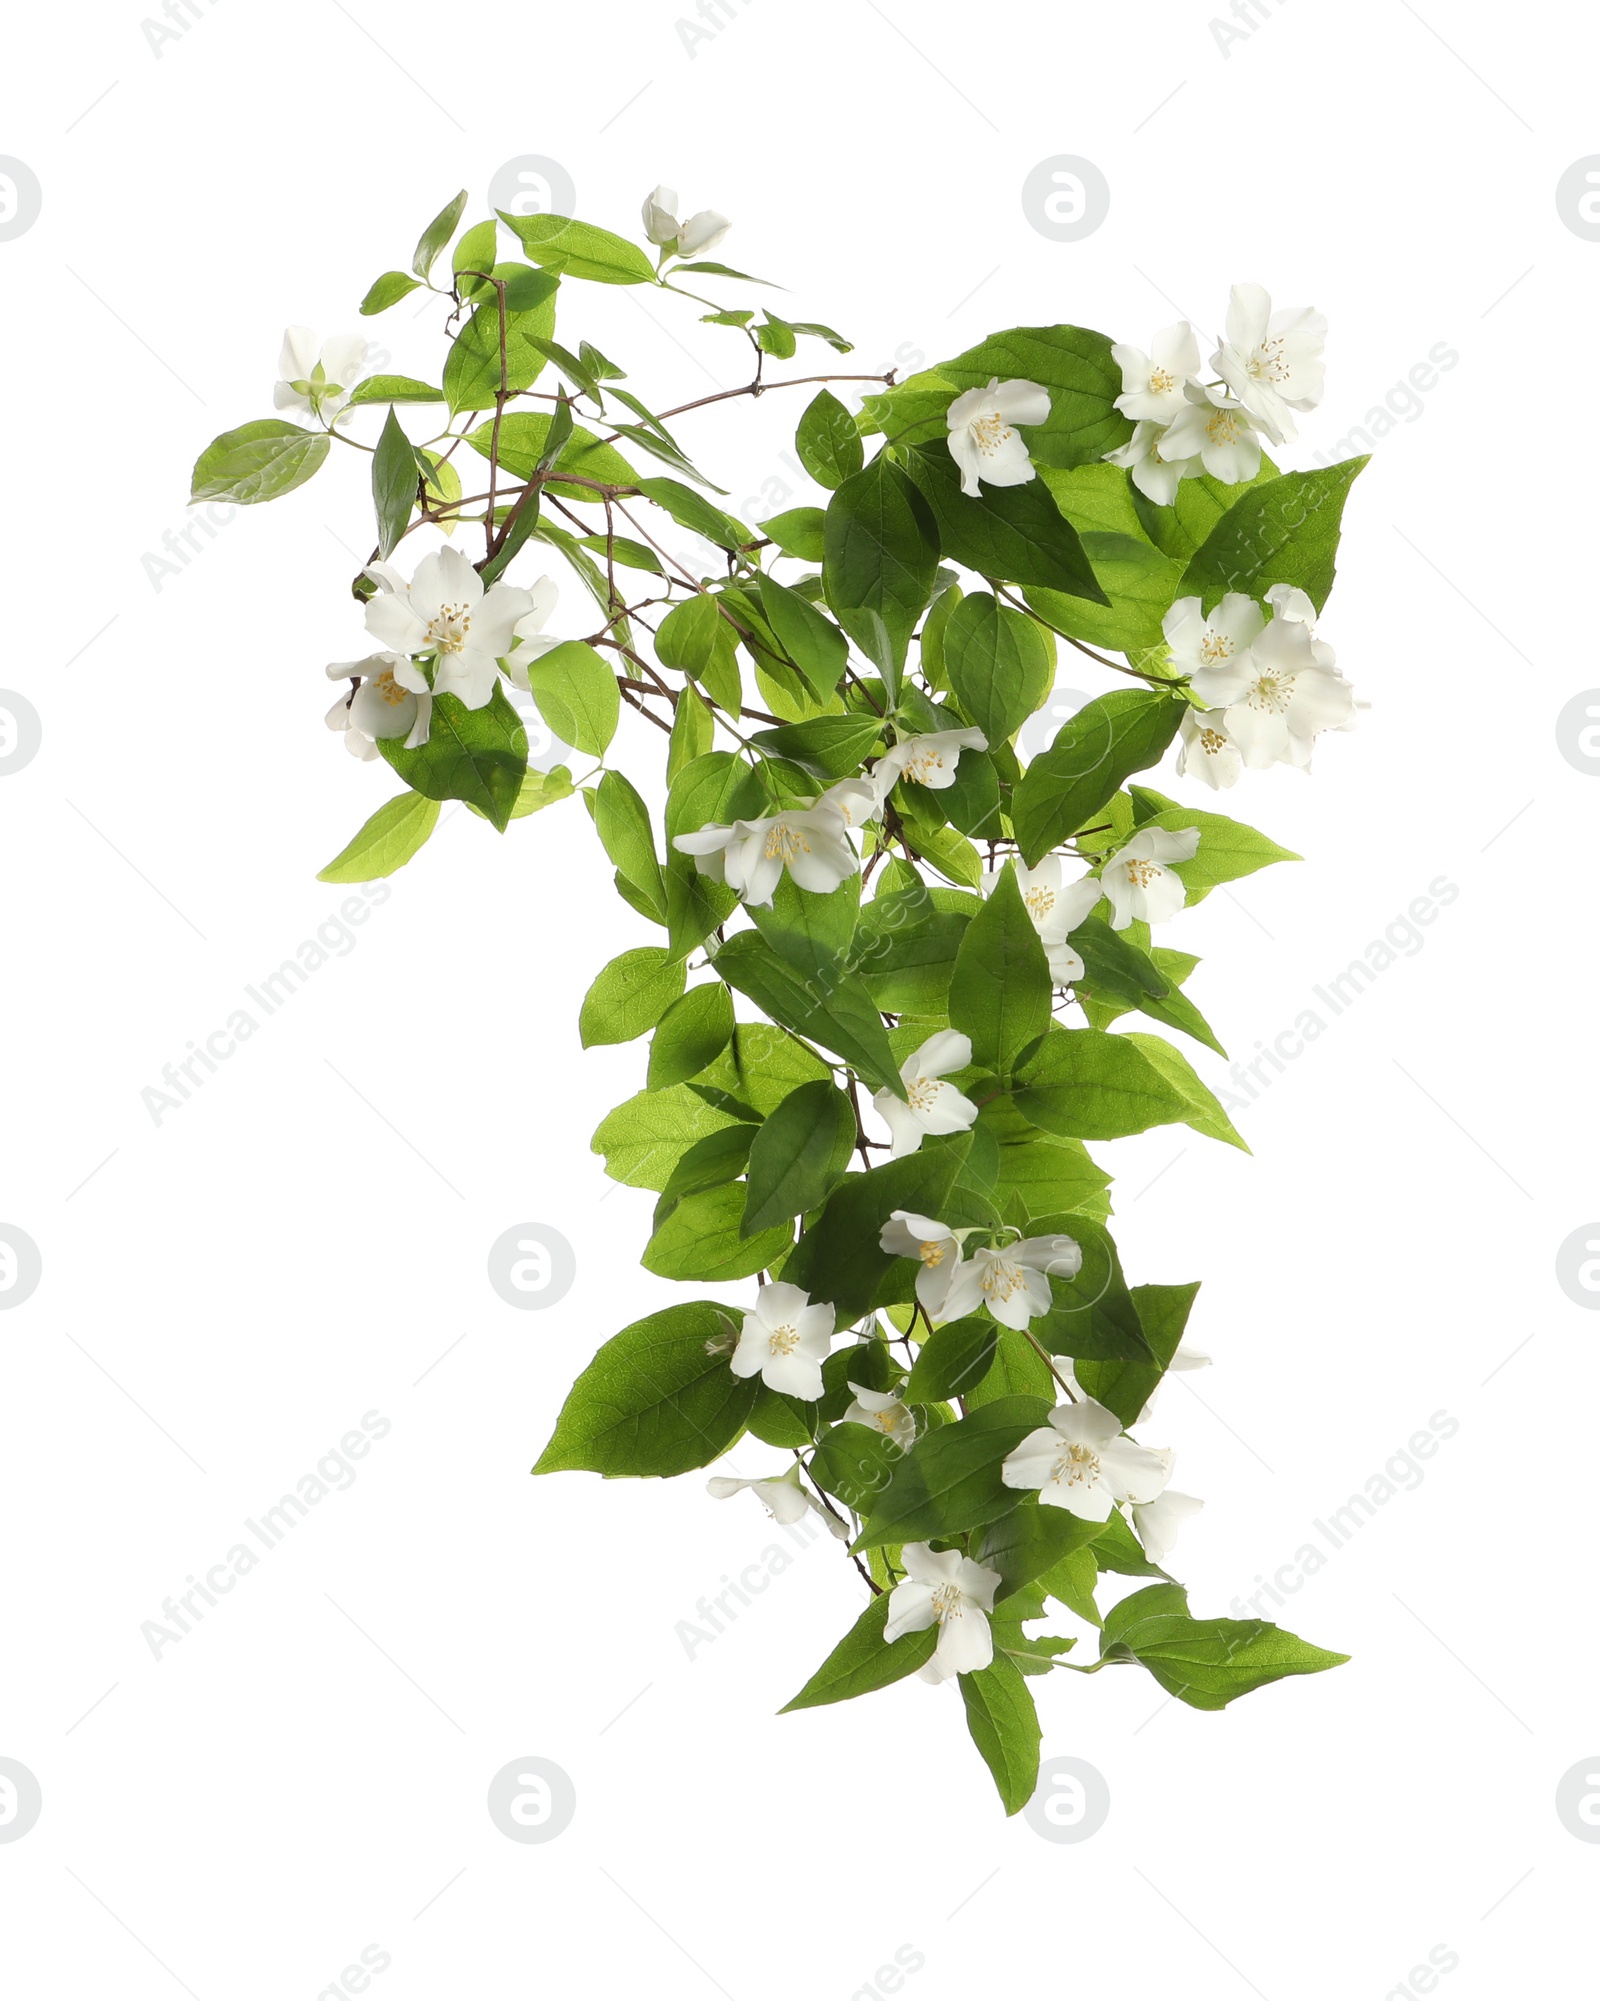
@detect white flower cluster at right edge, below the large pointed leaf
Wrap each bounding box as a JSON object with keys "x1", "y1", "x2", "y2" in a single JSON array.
[{"x1": 1162, "y1": 584, "x2": 1362, "y2": 788}]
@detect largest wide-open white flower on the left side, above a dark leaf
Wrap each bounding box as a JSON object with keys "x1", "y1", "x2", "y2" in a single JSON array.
[{"x1": 366, "y1": 548, "x2": 534, "y2": 708}]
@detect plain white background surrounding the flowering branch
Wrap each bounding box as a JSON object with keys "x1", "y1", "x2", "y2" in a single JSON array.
[{"x1": 0, "y1": 0, "x2": 1600, "y2": 2001}]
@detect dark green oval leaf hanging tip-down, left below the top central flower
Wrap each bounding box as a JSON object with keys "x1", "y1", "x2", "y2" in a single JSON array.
[{"x1": 820, "y1": 454, "x2": 938, "y2": 696}]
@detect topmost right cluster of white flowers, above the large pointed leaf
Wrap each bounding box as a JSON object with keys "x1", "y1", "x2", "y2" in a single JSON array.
[{"x1": 1106, "y1": 284, "x2": 1328, "y2": 506}]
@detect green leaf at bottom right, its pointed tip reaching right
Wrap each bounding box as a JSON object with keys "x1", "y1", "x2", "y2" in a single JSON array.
[{"x1": 1100, "y1": 1585, "x2": 1350, "y2": 1709}]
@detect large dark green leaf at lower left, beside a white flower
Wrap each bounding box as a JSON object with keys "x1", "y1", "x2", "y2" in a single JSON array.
[{"x1": 534, "y1": 1299, "x2": 756, "y2": 1479}]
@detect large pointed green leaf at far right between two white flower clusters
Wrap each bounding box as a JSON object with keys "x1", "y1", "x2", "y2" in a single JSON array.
[{"x1": 1178, "y1": 458, "x2": 1366, "y2": 610}]
